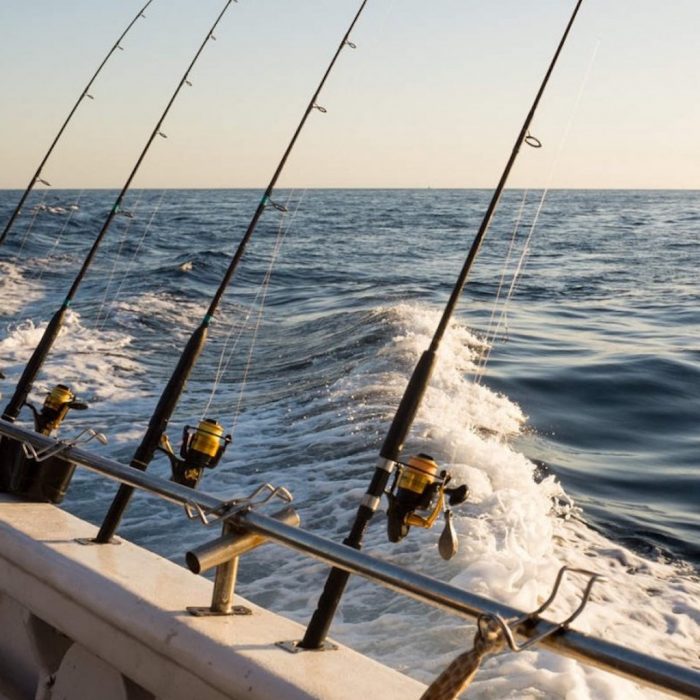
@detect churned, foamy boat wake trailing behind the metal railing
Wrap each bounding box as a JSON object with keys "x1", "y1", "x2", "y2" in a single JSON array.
[{"x1": 0, "y1": 231, "x2": 700, "y2": 700}]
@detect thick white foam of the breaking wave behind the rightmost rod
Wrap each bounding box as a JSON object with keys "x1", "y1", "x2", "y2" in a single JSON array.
[{"x1": 232, "y1": 306, "x2": 700, "y2": 700}]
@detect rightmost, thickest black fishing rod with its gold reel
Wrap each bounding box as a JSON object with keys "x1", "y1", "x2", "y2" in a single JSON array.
[{"x1": 299, "y1": 0, "x2": 583, "y2": 649}]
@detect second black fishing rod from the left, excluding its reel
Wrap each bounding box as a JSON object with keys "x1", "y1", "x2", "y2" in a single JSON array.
[{"x1": 2, "y1": 0, "x2": 234, "y2": 438}]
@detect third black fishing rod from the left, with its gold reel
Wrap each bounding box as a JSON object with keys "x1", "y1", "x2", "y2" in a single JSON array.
[{"x1": 95, "y1": 0, "x2": 368, "y2": 544}]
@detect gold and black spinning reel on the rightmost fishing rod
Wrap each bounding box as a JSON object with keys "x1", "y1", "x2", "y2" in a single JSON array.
[{"x1": 386, "y1": 453, "x2": 469, "y2": 559}]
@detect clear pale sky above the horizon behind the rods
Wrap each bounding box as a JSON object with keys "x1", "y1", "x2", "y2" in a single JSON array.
[{"x1": 0, "y1": 0, "x2": 700, "y2": 189}]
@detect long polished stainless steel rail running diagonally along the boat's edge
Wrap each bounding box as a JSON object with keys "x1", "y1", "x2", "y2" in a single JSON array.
[{"x1": 0, "y1": 420, "x2": 700, "y2": 698}]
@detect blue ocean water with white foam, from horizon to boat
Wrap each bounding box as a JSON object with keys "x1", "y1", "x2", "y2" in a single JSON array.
[{"x1": 0, "y1": 190, "x2": 700, "y2": 700}]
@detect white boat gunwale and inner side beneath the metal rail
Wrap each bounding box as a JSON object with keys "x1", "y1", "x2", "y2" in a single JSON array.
[{"x1": 0, "y1": 495, "x2": 424, "y2": 700}]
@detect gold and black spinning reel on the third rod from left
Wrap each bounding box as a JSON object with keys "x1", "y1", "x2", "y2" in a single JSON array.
[{"x1": 158, "y1": 418, "x2": 231, "y2": 489}]
